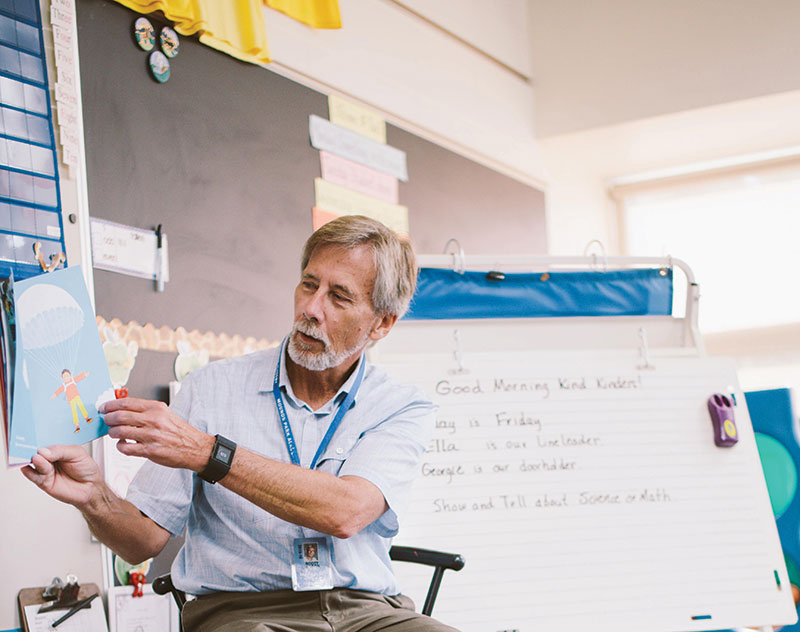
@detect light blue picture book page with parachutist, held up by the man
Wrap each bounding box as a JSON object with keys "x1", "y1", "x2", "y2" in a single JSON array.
[{"x1": 7, "y1": 266, "x2": 113, "y2": 464}]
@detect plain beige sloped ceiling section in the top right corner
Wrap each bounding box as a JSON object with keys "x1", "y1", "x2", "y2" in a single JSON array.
[{"x1": 528, "y1": 0, "x2": 800, "y2": 138}]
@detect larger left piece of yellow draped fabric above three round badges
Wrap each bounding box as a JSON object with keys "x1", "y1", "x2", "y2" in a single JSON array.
[{"x1": 111, "y1": 0, "x2": 270, "y2": 64}]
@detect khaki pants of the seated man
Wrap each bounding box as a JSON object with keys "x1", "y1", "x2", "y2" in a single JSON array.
[{"x1": 182, "y1": 588, "x2": 458, "y2": 632}]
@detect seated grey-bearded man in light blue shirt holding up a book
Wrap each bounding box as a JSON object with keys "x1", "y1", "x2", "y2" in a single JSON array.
[{"x1": 24, "y1": 217, "x2": 452, "y2": 632}]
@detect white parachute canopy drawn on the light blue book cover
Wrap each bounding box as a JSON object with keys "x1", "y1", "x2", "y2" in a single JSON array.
[{"x1": 16, "y1": 283, "x2": 84, "y2": 380}]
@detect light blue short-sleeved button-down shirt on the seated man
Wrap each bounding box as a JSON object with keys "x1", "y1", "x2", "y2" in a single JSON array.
[{"x1": 127, "y1": 338, "x2": 434, "y2": 595}]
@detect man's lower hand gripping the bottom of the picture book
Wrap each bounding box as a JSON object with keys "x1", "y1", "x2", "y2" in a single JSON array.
[{"x1": 22, "y1": 445, "x2": 103, "y2": 509}]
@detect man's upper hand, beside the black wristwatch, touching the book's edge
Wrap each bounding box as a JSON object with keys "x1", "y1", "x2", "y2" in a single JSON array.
[{"x1": 100, "y1": 397, "x2": 214, "y2": 472}]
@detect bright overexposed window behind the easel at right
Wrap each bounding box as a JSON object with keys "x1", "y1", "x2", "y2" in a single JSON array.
[{"x1": 615, "y1": 161, "x2": 800, "y2": 334}]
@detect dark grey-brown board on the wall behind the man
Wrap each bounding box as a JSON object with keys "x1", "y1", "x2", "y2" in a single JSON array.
[{"x1": 77, "y1": 0, "x2": 546, "y2": 398}]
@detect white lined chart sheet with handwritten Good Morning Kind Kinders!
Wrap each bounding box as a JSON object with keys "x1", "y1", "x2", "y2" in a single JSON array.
[{"x1": 373, "y1": 344, "x2": 796, "y2": 632}]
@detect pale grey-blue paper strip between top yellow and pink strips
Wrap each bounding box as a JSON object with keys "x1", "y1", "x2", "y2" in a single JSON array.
[{"x1": 308, "y1": 114, "x2": 408, "y2": 182}]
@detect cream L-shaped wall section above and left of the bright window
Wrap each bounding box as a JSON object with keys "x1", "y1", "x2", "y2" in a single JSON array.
[{"x1": 540, "y1": 91, "x2": 800, "y2": 256}]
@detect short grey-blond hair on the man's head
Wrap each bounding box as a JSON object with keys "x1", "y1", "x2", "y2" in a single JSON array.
[{"x1": 300, "y1": 215, "x2": 417, "y2": 318}]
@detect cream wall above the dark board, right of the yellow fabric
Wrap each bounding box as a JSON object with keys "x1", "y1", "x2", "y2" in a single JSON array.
[{"x1": 264, "y1": 0, "x2": 542, "y2": 182}]
